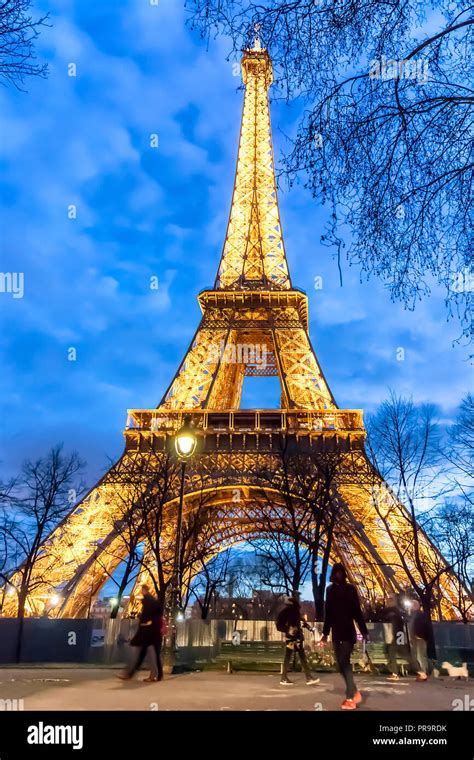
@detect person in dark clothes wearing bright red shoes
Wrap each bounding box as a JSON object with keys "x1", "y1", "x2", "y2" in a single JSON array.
[{"x1": 320, "y1": 562, "x2": 368, "y2": 710}]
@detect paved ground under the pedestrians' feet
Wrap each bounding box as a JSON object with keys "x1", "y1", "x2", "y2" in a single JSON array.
[{"x1": 0, "y1": 668, "x2": 468, "y2": 711}]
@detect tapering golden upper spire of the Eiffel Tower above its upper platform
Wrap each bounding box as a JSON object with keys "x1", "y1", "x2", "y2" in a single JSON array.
[{"x1": 215, "y1": 45, "x2": 291, "y2": 290}]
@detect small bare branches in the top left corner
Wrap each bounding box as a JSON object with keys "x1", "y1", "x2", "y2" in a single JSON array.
[{"x1": 0, "y1": 0, "x2": 49, "y2": 90}]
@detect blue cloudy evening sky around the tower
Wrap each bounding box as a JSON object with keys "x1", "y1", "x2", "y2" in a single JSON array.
[{"x1": 0, "y1": 0, "x2": 469, "y2": 485}]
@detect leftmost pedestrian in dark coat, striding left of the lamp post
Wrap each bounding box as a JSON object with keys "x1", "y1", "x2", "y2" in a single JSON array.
[{"x1": 119, "y1": 584, "x2": 163, "y2": 683}]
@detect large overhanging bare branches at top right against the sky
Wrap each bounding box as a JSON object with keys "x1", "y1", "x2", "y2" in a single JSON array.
[{"x1": 186, "y1": 0, "x2": 474, "y2": 337}]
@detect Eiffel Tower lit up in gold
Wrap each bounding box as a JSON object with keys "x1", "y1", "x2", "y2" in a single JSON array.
[{"x1": 3, "y1": 39, "x2": 457, "y2": 619}]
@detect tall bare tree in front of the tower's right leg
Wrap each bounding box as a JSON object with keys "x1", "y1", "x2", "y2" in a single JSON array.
[{"x1": 367, "y1": 394, "x2": 460, "y2": 644}]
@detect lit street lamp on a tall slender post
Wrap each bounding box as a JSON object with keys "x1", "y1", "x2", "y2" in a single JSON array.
[{"x1": 170, "y1": 417, "x2": 197, "y2": 653}]
